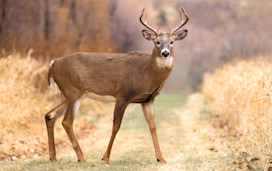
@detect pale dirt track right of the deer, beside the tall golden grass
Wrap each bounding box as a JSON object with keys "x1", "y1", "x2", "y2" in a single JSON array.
[{"x1": 157, "y1": 94, "x2": 232, "y2": 170}]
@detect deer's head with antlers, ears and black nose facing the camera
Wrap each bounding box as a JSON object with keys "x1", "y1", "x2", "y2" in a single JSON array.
[{"x1": 140, "y1": 8, "x2": 188, "y2": 58}]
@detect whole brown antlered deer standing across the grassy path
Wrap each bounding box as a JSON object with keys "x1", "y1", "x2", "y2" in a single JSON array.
[{"x1": 45, "y1": 7, "x2": 189, "y2": 164}]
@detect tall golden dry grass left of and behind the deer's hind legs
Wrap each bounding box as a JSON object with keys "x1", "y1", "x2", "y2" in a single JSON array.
[{"x1": 0, "y1": 52, "x2": 111, "y2": 161}]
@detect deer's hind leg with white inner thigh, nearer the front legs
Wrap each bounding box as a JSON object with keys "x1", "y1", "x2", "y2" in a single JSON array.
[{"x1": 62, "y1": 95, "x2": 86, "y2": 162}]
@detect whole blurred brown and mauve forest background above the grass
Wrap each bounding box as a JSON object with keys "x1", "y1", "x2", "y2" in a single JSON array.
[{"x1": 0, "y1": 0, "x2": 272, "y2": 92}]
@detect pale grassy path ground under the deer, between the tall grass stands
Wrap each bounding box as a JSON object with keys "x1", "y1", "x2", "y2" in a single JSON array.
[{"x1": 0, "y1": 94, "x2": 263, "y2": 171}]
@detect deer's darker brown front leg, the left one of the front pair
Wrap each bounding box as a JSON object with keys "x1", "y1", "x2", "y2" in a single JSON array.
[{"x1": 102, "y1": 99, "x2": 128, "y2": 163}]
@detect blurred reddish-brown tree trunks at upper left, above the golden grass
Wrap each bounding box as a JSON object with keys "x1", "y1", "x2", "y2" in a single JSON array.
[{"x1": 0, "y1": 0, "x2": 115, "y2": 56}]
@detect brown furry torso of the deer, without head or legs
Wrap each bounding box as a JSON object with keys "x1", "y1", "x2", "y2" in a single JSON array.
[{"x1": 49, "y1": 52, "x2": 172, "y2": 103}]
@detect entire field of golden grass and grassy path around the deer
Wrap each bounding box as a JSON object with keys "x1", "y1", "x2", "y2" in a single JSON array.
[{"x1": 0, "y1": 52, "x2": 272, "y2": 170}]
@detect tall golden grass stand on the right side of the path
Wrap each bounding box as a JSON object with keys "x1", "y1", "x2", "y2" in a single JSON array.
[{"x1": 202, "y1": 57, "x2": 272, "y2": 154}]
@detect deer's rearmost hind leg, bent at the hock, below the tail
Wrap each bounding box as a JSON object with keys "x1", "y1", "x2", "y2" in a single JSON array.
[{"x1": 45, "y1": 100, "x2": 67, "y2": 161}]
